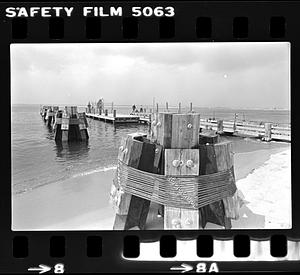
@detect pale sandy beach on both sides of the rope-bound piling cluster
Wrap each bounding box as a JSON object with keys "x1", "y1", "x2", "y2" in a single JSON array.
[{"x1": 12, "y1": 143, "x2": 291, "y2": 231}]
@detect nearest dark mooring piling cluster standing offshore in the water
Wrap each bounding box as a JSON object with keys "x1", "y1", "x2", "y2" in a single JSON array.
[{"x1": 54, "y1": 106, "x2": 89, "y2": 142}]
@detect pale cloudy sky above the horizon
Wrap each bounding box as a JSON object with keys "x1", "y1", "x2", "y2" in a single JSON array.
[{"x1": 11, "y1": 42, "x2": 290, "y2": 109}]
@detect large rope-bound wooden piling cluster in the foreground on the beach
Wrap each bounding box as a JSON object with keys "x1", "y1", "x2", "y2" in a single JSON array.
[{"x1": 110, "y1": 112, "x2": 238, "y2": 230}]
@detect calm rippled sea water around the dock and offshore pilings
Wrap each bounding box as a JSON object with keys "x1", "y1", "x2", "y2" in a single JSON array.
[{"x1": 11, "y1": 105, "x2": 290, "y2": 194}]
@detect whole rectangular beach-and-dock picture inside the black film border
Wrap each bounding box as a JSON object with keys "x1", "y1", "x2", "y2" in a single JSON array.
[{"x1": 10, "y1": 42, "x2": 292, "y2": 231}]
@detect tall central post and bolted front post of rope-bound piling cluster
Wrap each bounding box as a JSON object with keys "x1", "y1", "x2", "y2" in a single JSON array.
[{"x1": 152, "y1": 113, "x2": 200, "y2": 229}]
